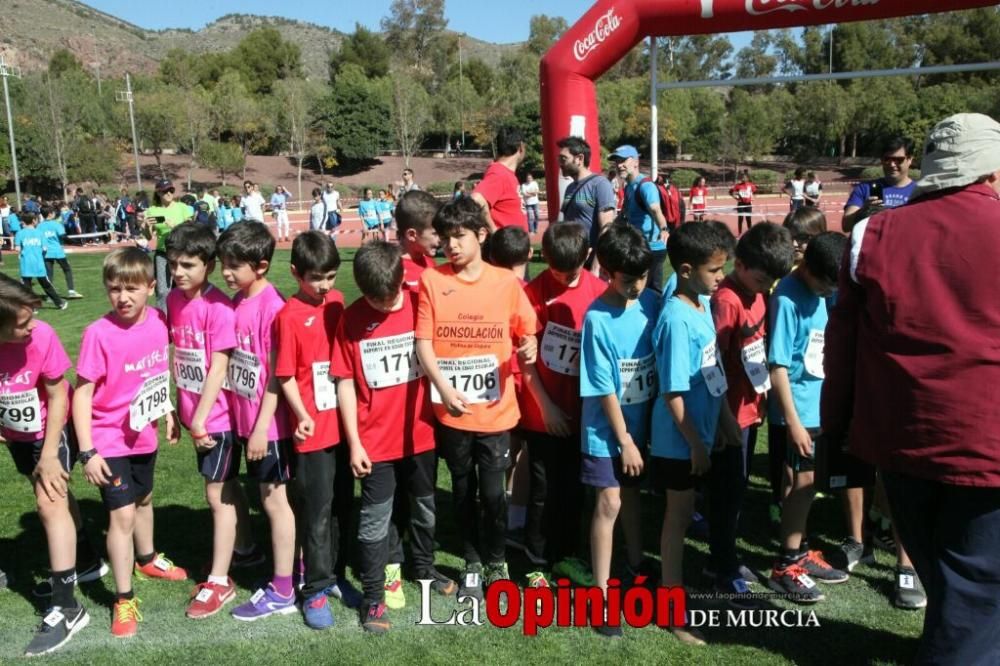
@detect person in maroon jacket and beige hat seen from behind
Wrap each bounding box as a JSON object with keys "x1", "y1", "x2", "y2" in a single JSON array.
[{"x1": 822, "y1": 114, "x2": 1000, "y2": 665}]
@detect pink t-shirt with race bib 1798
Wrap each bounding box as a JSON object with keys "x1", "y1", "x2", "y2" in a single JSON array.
[{"x1": 76, "y1": 308, "x2": 170, "y2": 458}]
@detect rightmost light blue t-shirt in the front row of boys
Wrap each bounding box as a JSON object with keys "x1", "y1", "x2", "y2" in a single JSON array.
[{"x1": 767, "y1": 273, "x2": 827, "y2": 428}]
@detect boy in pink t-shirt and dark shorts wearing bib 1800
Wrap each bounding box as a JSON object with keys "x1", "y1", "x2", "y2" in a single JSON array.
[{"x1": 166, "y1": 222, "x2": 264, "y2": 620}]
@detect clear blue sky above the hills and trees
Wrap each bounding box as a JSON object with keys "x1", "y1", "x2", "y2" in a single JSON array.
[{"x1": 85, "y1": 0, "x2": 749, "y2": 48}]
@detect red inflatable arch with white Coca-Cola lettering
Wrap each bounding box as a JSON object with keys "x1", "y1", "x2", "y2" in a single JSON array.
[{"x1": 540, "y1": 0, "x2": 996, "y2": 220}]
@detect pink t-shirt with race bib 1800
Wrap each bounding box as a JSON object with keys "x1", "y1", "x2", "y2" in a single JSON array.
[{"x1": 167, "y1": 284, "x2": 236, "y2": 434}]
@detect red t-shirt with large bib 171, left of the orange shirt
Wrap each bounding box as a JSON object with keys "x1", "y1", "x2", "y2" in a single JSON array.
[{"x1": 330, "y1": 291, "x2": 434, "y2": 463}]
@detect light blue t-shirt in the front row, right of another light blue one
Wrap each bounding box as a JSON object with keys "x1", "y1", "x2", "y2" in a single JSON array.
[{"x1": 652, "y1": 296, "x2": 725, "y2": 460}]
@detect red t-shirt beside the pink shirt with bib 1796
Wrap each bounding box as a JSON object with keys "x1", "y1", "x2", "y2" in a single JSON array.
[{"x1": 274, "y1": 289, "x2": 344, "y2": 453}]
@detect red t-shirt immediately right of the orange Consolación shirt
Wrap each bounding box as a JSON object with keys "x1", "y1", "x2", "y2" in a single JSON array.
[{"x1": 520, "y1": 270, "x2": 608, "y2": 432}]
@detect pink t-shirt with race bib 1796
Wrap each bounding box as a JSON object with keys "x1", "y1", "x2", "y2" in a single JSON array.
[{"x1": 229, "y1": 284, "x2": 292, "y2": 441}]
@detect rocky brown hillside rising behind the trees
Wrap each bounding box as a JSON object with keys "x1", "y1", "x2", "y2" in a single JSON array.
[{"x1": 0, "y1": 0, "x2": 520, "y2": 81}]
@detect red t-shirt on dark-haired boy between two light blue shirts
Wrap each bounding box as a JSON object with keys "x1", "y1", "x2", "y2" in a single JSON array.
[{"x1": 712, "y1": 276, "x2": 769, "y2": 428}]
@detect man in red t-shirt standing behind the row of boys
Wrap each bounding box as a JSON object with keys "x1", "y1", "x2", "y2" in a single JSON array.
[{"x1": 472, "y1": 127, "x2": 528, "y2": 233}]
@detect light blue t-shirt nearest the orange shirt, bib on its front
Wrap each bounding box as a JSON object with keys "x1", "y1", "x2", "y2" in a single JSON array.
[{"x1": 580, "y1": 289, "x2": 660, "y2": 458}]
